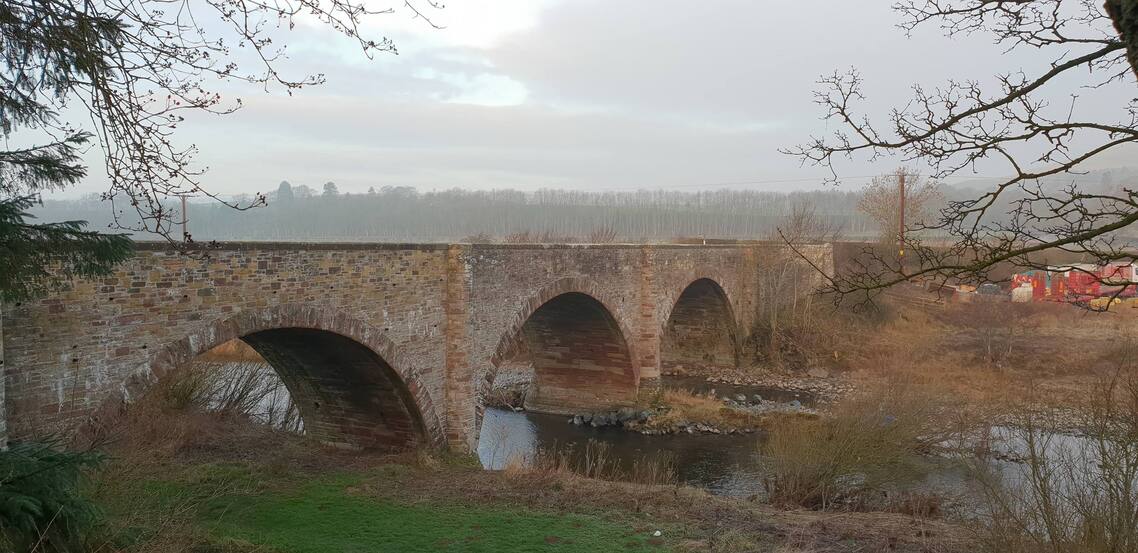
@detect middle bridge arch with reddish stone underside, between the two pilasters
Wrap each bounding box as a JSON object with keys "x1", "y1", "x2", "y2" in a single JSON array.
[{"x1": 479, "y1": 278, "x2": 640, "y2": 413}]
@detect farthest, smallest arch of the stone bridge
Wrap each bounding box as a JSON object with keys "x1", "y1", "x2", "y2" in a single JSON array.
[{"x1": 660, "y1": 277, "x2": 741, "y2": 371}]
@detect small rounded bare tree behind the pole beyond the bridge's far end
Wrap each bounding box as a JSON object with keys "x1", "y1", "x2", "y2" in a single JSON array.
[{"x1": 857, "y1": 167, "x2": 943, "y2": 244}]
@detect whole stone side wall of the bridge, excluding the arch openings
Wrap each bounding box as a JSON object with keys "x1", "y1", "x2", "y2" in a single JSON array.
[{"x1": 0, "y1": 244, "x2": 828, "y2": 446}]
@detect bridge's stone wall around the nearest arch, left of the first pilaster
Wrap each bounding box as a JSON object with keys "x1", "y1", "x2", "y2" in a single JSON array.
[{"x1": 3, "y1": 245, "x2": 446, "y2": 441}]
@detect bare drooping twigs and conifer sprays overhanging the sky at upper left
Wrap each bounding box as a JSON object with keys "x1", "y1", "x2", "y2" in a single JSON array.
[{"x1": 0, "y1": 0, "x2": 439, "y2": 238}]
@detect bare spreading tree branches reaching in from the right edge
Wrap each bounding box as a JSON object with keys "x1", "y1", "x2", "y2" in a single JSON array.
[{"x1": 784, "y1": 0, "x2": 1138, "y2": 307}]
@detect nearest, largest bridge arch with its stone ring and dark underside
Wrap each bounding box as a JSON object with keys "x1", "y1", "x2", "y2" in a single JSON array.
[{"x1": 123, "y1": 304, "x2": 445, "y2": 447}]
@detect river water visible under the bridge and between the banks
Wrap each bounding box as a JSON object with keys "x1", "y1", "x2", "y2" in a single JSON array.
[{"x1": 202, "y1": 363, "x2": 1094, "y2": 503}]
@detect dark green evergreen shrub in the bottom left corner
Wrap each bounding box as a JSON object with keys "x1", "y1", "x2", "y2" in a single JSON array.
[{"x1": 0, "y1": 443, "x2": 102, "y2": 553}]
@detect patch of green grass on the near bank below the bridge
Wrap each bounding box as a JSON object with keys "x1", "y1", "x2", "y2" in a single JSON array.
[{"x1": 99, "y1": 463, "x2": 671, "y2": 553}]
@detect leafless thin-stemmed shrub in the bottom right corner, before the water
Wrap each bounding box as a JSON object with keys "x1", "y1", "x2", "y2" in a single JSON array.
[{"x1": 973, "y1": 373, "x2": 1138, "y2": 553}]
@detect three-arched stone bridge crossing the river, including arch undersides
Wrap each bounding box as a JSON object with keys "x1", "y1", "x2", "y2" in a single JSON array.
[{"x1": 0, "y1": 242, "x2": 832, "y2": 448}]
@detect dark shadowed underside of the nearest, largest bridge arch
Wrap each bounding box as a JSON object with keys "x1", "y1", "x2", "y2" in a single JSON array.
[{"x1": 241, "y1": 328, "x2": 426, "y2": 448}]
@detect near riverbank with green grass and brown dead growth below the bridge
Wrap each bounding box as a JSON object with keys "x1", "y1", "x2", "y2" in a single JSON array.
[{"x1": 89, "y1": 414, "x2": 965, "y2": 553}]
